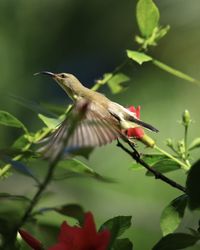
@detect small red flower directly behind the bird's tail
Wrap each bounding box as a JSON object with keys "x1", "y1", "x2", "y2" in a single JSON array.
[{"x1": 126, "y1": 106, "x2": 145, "y2": 139}]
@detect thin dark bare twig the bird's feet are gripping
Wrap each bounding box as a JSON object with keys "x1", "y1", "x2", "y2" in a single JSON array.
[{"x1": 117, "y1": 140, "x2": 186, "y2": 193}]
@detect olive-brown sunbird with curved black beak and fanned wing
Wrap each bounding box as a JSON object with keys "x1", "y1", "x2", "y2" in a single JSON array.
[{"x1": 34, "y1": 71, "x2": 158, "y2": 159}]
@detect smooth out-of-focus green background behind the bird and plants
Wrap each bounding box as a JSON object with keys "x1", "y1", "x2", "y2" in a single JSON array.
[{"x1": 0, "y1": 0, "x2": 200, "y2": 250}]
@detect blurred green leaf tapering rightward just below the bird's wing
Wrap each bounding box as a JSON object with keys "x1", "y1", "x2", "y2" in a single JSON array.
[{"x1": 57, "y1": 159, "x2": 113, "y2": 182}]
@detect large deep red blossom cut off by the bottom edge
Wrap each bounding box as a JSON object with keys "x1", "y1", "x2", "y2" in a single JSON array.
[{"x1": 48, "y1": 212, "x2": 110, "y2": 250}]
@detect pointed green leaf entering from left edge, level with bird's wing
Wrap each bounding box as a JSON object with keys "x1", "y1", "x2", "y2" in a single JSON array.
[{"x1": 0, "y1": 110, "x2": 28, "y2": 133}]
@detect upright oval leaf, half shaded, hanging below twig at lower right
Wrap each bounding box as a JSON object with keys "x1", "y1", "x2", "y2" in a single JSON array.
[{"x1": 160, "y1": 194, "x2": 188, "y2": 235}]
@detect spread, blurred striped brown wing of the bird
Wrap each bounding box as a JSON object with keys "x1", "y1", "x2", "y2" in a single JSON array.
[{"x1": 39, "y1": 100, "x2": 122, "y2": 158}]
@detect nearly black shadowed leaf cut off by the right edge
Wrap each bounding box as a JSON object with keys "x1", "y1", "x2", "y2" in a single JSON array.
[{"x1": 186, "y1": 160, "x2": 200, "y2": 210}]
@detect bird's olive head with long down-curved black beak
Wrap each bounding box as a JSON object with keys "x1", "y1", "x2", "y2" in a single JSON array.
[{"x1": 34, "y1": 71, "x2": 82, "y2": 99}]
